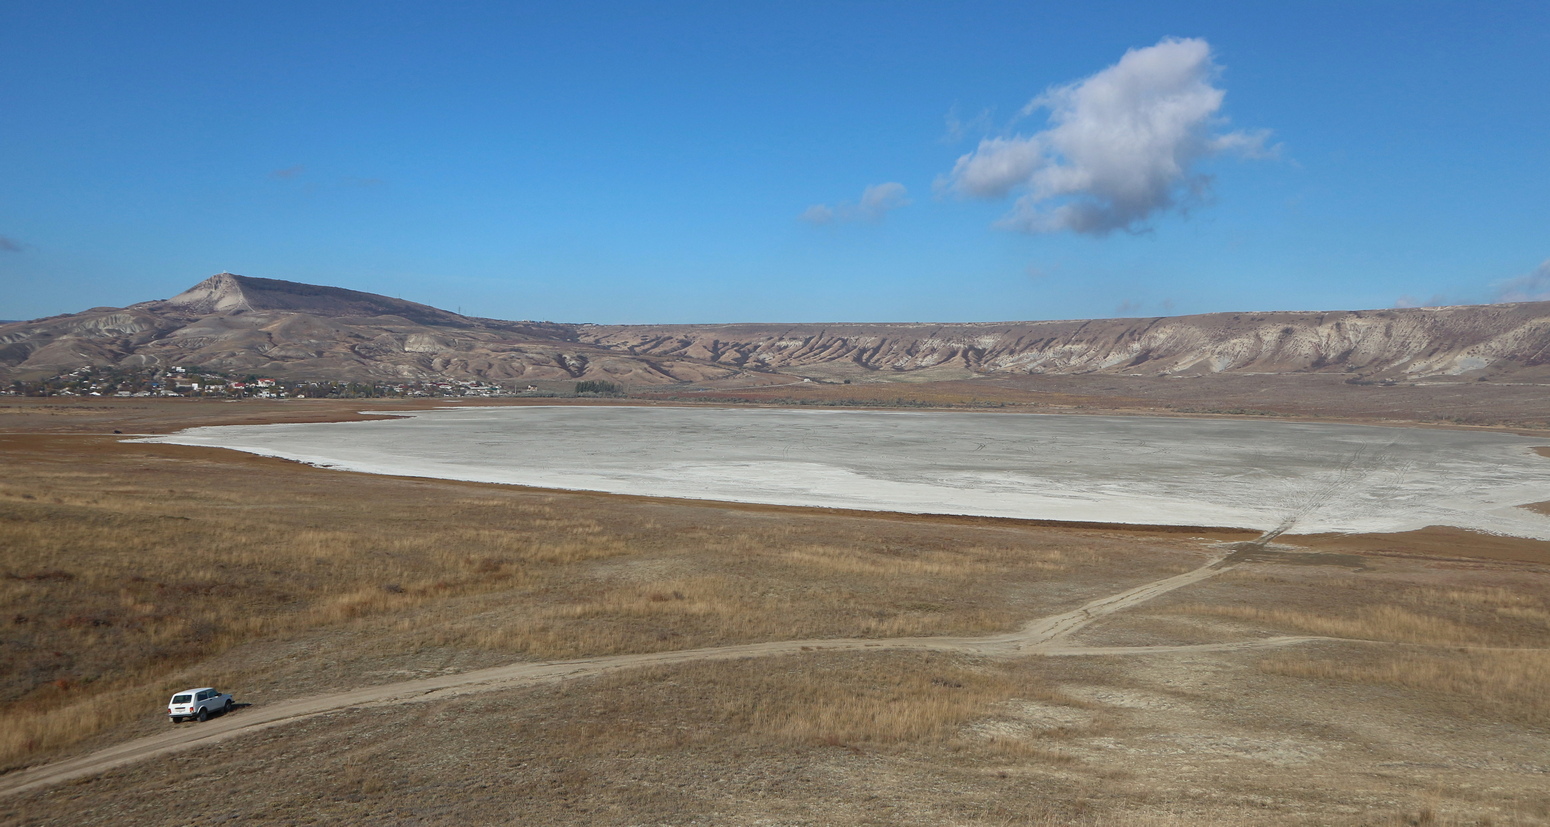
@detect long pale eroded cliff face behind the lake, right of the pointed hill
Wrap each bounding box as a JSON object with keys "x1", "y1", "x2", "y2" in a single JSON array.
[{"x1": 580, "y1": 302, "x2": 1550, "y2": 376}]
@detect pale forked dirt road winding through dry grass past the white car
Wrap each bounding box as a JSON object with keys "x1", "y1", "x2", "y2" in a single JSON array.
[{"x1": 0, "y1": 551, "x2": 1319, "y2": 796}]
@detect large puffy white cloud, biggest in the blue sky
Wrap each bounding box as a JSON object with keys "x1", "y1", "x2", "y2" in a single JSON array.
[{"x1": 941, "y1": 37, "x2": 1274, "y2": 235}]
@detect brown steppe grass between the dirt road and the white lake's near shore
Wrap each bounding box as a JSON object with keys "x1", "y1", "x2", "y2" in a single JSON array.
[{"x1": 0, "y1": 437, "x2": 1171, "y2": 777}]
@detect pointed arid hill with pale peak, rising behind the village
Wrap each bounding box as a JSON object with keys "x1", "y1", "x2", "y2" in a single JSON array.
[{"x1": 0, "y1": 273, "x2": 730, "y2": 384}]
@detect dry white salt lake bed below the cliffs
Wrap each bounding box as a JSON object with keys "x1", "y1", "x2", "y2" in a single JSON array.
[{"x1": 143, "y1": 406, "x2": 1550, "y2": 540}]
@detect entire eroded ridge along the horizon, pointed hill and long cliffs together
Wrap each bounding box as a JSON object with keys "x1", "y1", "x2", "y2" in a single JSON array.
[{"x1": 0, "y1": 273, "x2": 1550, "y2": 386}]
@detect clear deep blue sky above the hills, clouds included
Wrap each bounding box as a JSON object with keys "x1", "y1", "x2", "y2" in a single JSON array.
[{"x1": 0, "y1": 0, "x2": 1550, "y2": 322}]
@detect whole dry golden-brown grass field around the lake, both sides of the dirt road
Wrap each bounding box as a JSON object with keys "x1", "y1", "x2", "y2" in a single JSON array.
[{"x1": 0, "y1": 401, "x2": 1550, "y2": 825}]
